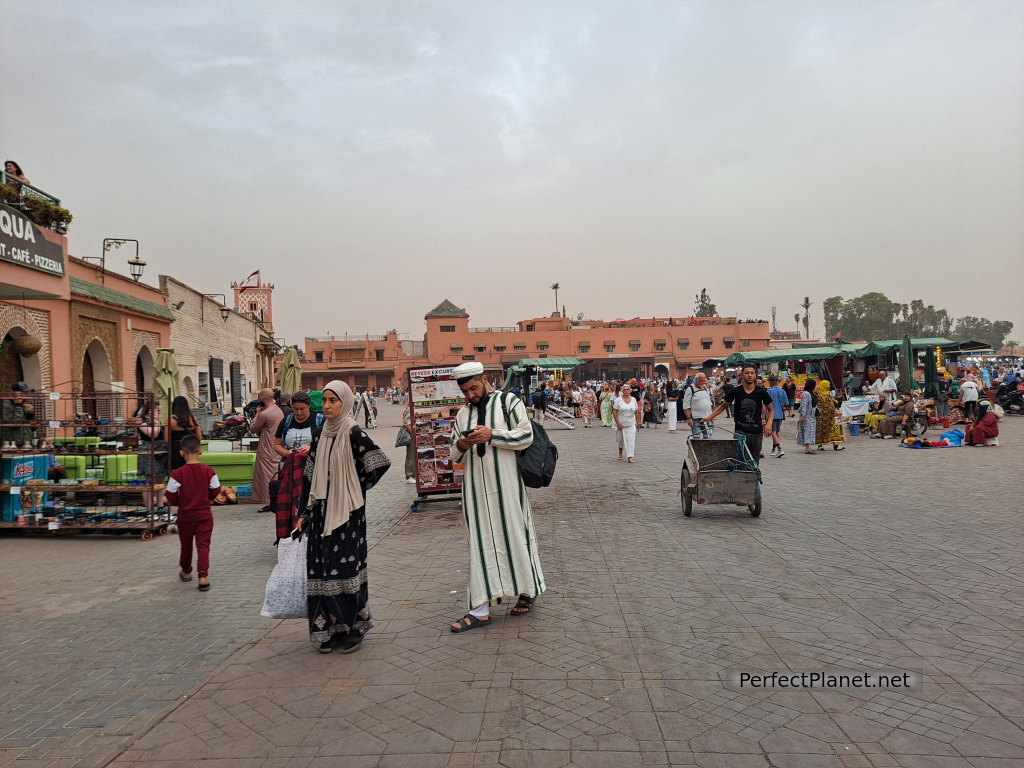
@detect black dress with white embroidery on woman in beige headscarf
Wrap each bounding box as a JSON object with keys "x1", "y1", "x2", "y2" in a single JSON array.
[{"x1": 299, "y1": 427, "x2": 391, "y2": 643}]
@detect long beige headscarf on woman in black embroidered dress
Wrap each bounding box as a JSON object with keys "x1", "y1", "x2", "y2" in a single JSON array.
[{"x1": 306, "y1": 381, "x2": 364, "y2": 536}]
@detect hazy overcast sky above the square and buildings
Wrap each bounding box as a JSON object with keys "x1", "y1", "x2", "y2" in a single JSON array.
[{"x1": 0, "y1": 0, "x2": 1024, "y2": 344}]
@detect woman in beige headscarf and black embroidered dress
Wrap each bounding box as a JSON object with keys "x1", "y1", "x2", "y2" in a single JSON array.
[{"x1": 296, "y1": 381, "x2": 391, "y2": 653}]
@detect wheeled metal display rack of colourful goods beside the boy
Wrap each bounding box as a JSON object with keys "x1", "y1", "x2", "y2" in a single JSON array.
[{"x1": 0, "y1": 392, "x2": 174, "y2": 541}]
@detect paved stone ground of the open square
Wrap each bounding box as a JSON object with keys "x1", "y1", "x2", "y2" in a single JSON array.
[{"x1": 0, "y1": 408, "x2": 1024, "y2": 768}]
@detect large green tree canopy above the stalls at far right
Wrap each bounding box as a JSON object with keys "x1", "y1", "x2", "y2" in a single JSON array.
[{"x1": 822, "y1": 293, "x2": 1014, "y2": 349}]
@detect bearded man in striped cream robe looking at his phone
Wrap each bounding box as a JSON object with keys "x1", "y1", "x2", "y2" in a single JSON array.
[{"x1": 452, "y1": 362, "x2": 546, "y2": 632}]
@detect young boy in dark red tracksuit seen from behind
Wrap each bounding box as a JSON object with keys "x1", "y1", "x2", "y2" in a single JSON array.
[{"x1": 167, "y1": 434, "x2": 220, "y2": 592}]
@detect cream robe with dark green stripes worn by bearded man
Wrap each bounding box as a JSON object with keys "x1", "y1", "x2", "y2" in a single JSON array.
[{"x1": 452, "y1": 391, "x2": 545, "y2": 608}]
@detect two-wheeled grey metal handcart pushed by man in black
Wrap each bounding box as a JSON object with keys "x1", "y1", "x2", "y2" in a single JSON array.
[{"x1": 680, "y1": 437, "x2": 761, "y2": 517}]
